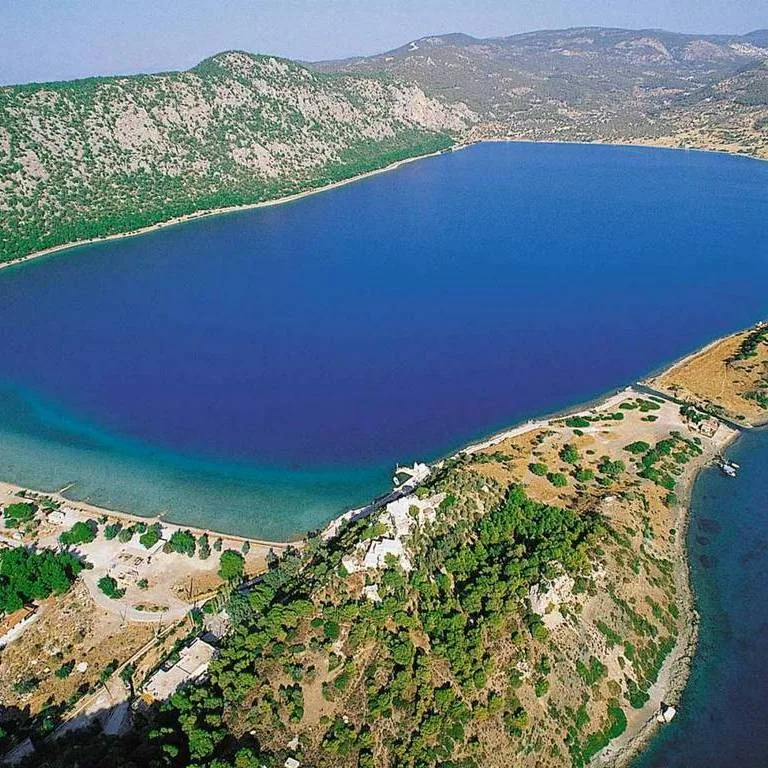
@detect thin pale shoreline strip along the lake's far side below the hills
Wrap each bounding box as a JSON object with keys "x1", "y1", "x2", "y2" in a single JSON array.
[{"x1": 0, "y1": 137, "x2": 768, "y2": 276}]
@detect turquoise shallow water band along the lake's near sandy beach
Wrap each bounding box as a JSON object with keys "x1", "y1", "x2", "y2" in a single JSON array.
[{"x1": 0, "y1": 390, "x2": 380, "y2": 541}]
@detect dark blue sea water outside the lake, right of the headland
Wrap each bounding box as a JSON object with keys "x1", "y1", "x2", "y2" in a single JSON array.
[{"x1": 635, "y1": 429, "x2": 768, "y2": 768}]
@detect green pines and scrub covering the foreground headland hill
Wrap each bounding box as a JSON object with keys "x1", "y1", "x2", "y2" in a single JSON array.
[{"x1": 4, "y1": 420, "x2": 688, "y2": 768}]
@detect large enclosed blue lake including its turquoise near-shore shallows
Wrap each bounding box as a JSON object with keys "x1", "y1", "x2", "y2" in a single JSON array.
[{"x1": 0, "y1": 144, "x2": 768, "y2": 538}]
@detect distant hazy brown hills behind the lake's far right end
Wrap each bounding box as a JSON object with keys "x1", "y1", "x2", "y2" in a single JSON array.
[{"x1": 317, "y1": 27, "x2": 768, "y2": 155}]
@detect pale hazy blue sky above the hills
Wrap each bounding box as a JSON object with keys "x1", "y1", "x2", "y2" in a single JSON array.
[{"x1": 0, "y1": 0, "x2": 768, "y2": 83}]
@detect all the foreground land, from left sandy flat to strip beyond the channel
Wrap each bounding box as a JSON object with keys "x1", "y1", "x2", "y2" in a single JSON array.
[{"x1": 0, "y1": 325, "x2": 768, "y2": 768}]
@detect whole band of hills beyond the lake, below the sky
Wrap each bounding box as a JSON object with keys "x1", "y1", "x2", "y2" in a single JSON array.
[{"x1": 0, "y1": 28, "x2": 768, "y2": 261}]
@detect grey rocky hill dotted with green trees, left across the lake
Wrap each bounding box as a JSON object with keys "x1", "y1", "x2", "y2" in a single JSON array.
[{"x1": 0, "y1": 51, "x2": 475, "y2": 261}]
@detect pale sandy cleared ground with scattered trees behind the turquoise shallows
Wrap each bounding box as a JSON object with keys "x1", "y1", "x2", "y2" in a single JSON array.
[{"x1": 0, "y1": 484, "x2": 288, "y2": 731}]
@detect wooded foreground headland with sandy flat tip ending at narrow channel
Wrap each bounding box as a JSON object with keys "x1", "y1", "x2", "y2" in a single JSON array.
[{"x1": 4, "y1": 378, "x2": 752, "y2": 768}]
